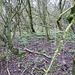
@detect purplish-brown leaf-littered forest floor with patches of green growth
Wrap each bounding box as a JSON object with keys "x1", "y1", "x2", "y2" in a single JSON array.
[{"x1": 0, "y1": 33, "x2": 75, "y2": 75}]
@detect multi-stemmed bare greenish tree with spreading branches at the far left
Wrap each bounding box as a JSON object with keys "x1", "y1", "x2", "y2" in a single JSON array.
[{"x1": 0, "y1": 0, "x2": 23, "y2": 49}]
